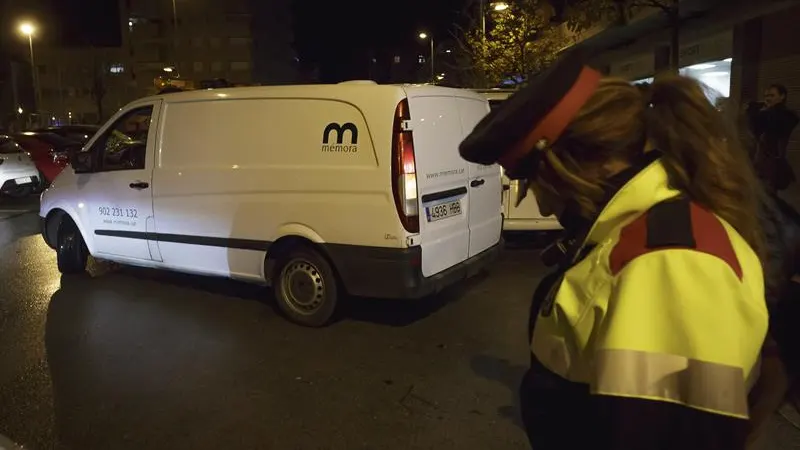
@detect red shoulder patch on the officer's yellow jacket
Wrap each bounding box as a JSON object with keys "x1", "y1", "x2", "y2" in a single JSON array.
[{"x1": 609, "y1": 203, "x2": 743, "y2": 280}]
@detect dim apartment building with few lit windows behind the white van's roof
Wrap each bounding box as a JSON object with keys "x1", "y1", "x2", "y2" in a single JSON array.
[{"x1": 28, "y1": 0, "x2": 297, "y2": 123}]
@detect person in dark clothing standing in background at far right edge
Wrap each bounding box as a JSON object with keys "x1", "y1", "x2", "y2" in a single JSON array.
[{"x1": 747, "y1": 84, "x2": 798, "y2": 192}]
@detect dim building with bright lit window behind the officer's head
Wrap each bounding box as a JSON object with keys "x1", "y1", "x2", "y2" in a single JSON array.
[{"x1": 560, "y1": 0, "x2": 800, "y2": 202}]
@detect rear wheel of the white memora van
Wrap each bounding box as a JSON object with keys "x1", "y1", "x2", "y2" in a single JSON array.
[{"x1": 272, "y1": 247, "x2": 339, "y2": 327}]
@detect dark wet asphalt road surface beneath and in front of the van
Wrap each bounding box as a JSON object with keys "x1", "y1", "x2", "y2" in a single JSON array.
[{"x1": 0, "y1": 198, "x2": 800, "y2": 450}]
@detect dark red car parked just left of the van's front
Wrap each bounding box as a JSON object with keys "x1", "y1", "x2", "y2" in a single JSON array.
[{"x1": 13, "y1": 131, "x2": 82, "y2": 186}]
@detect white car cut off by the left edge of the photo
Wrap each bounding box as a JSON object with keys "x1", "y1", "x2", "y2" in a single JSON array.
[{"x1": 0, "y1": 135, "x2": 39, "y2": 197}]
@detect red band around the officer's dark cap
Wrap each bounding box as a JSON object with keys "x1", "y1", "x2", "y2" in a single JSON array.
[{"x1": 498, "y1": 67, "x2": 603, "y2": 170}]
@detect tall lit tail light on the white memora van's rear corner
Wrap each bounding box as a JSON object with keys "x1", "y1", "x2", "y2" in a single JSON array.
[{"x1": 392, "y1": 100, "x2": 419, "y2": 233}]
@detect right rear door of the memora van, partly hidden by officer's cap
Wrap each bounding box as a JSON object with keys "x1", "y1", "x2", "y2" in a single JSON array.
[{"x1": 455, "y1": 97, "x2": 503, "y2": 257}]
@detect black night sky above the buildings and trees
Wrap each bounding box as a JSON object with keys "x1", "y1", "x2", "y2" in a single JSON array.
[{"x1": 0, "y1": 0, "x2": 468, "y2": 82}]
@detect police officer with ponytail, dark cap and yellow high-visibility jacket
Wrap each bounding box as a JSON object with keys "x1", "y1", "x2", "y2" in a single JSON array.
[{"x1": 460, "y1": 54, "x2": 768, "y2": 450}]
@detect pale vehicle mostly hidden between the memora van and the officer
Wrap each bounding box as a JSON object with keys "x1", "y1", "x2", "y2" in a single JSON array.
[{"x1": 475, "y1": 89, "x2": 562, "y2": 231}]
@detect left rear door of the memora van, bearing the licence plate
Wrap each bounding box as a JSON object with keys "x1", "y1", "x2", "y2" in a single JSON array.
[{"x1": 407, "y1": 93, "x2": 468, "y2": 277}]
